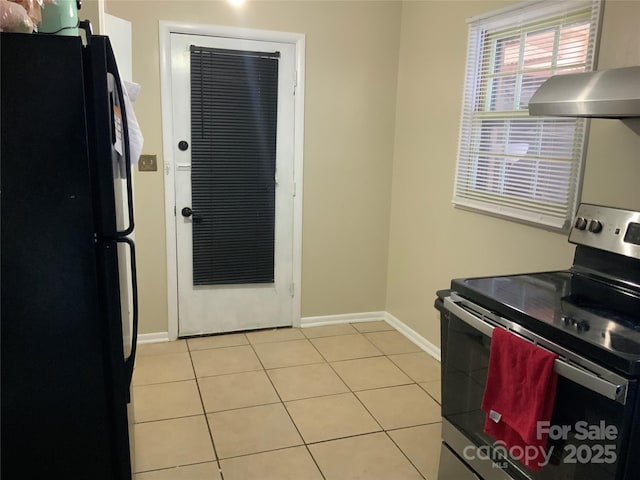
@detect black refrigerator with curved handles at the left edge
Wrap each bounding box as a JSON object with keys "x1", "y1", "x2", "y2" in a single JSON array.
[{"x1": 0, "y1": 33, "x2": 138, "y2": 480}]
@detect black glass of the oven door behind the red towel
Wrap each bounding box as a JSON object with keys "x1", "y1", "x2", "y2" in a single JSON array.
[{"x1": 442, "y1": 315, "x2": 635, "y2": 480}]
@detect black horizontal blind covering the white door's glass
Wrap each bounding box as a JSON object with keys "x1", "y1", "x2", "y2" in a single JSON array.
[{"x1": 191, "y1": 45, "x2": 279, "y2": 285}]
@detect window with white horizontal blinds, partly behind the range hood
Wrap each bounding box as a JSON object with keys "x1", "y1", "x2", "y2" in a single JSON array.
[{"x1": 453, "y1": 0, "x2": 601, "y2": 230}]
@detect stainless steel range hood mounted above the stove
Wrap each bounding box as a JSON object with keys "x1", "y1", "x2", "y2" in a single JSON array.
[{"x1": 529, "y1": 66, "x2": 640, "y2": 118}]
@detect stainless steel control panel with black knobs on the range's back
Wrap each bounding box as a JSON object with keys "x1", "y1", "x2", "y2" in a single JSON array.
[{"x1": 569, "y1": 203, "x2": 640, "y2": 259}]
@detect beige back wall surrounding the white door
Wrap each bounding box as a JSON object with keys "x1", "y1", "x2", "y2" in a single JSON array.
[{"x1": 106, "y1": 0, "x2": 401, "y2": 333}]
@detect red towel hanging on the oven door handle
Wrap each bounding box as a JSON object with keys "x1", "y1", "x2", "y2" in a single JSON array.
[{"x1": 482, "y1": 328, "x2": 558, "y2": 470}]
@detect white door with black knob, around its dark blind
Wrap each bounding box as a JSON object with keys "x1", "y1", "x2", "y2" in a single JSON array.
[{"x1": 171, "y1": 33, "x2": 295, "y2": 336}]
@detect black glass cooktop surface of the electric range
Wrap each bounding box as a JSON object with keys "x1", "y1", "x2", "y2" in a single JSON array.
[{"x1": 451, "y1": 271, "x2": 640, "y2": 375}]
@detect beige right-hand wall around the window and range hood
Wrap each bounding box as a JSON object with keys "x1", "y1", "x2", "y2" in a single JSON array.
[{"x1": 387, "y1": 1, "x2": 640, "y2": 345}]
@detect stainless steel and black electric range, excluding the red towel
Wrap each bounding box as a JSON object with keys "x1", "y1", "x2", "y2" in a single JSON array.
[{"x1": 436, "y1": 204, "x2": 640, "y2": 480}]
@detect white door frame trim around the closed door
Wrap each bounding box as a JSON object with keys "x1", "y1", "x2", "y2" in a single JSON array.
[{"x1": 158, "y1": 20, "x2": 306, "y2": 340}]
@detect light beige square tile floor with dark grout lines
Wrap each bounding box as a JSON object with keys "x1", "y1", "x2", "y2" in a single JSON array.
[{"x1": 133, "y1": 321, "x2": 440, "y2": 480}]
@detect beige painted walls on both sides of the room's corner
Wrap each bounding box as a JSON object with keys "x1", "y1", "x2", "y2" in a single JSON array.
[{"x1": 102, "y1": 0, "x2": 640, "y2": 345}]
